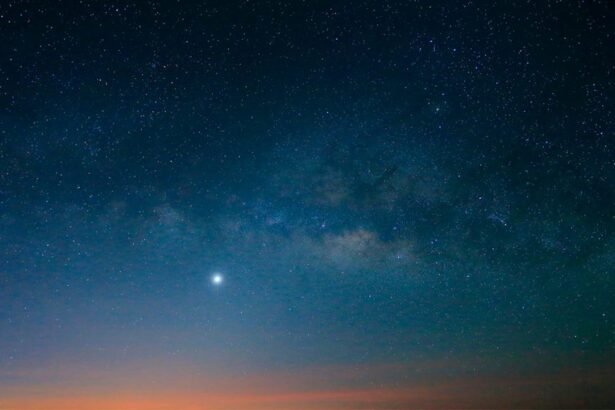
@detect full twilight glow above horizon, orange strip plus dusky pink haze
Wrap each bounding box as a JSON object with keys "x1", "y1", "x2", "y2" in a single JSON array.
[{"x1": 0, "y1": 362, "x2": 614, "y2": 410}]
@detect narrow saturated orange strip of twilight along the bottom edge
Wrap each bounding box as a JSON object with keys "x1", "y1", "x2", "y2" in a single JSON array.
[{"x1": 0, "y1": 382, "x2": 608, "y2": 410}]
